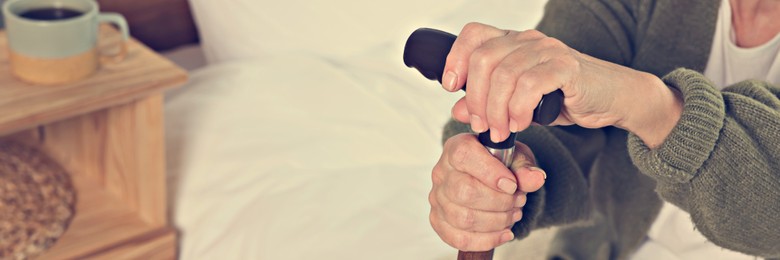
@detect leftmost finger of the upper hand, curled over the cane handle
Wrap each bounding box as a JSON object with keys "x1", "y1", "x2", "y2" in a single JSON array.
[{"x1": 442, "y1": 23, "x2": 506, "y2": 91}]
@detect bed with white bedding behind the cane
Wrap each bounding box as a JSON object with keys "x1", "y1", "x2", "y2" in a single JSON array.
[{"x1": 120, "y1": 0, "x2": 552, "y2": 259}]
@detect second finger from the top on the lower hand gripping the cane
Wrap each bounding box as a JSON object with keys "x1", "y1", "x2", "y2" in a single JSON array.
[{"x1": 438, "y1": 173, "x2": 522, "y2": 212}]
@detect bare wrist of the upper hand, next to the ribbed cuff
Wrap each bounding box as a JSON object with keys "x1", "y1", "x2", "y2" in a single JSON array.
[{"x1": 616, "y1": 72, "x2": 683, "y2": 149}]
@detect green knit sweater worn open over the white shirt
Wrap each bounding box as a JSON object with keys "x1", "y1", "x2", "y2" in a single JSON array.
[{"x1": 444, "y1": 0, "x2": 780, "y2": 259}]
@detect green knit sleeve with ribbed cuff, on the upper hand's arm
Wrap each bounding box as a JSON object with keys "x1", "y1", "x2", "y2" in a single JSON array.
[{"x1": 628, "y1": 69, "x2": 780, "y2": 258}]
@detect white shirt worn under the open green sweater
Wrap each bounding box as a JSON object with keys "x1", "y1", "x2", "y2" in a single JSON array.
[{"x1": 632, "y1": 0, "x2": 780, "y2": 260}]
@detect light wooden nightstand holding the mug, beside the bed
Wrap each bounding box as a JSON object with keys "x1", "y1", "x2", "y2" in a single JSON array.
[{"x1": 0, "y1": 27, "x2": 187, "y2": 259}]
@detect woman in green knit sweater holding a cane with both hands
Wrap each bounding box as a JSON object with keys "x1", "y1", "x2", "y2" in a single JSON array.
[{"x1": 429, "y1": 0, "x2": 780, "y2": 259}]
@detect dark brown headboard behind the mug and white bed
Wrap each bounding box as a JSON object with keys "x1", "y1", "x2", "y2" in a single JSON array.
[{"x1": 98, "y1": 0, "x2": 198, "y2": 51}]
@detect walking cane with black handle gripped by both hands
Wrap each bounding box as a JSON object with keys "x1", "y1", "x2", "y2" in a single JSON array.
[{"x1": 404, "y1": 28, "x2": 563, "y2": 260}]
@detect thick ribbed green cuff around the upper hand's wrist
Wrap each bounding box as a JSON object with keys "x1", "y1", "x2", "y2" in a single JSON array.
[{"x1": 628, "y1": 69, "x2": 725, "y2": 183}]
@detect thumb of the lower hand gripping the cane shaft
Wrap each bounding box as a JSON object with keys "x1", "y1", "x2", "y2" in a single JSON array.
[{"x1": 512, "y1": 142, "x2": 547, "y2": 192}]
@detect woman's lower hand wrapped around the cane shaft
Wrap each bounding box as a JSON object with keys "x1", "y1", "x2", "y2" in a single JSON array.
[{"x1": 428, "y1": 134, "x2": 546, "y2": 251}]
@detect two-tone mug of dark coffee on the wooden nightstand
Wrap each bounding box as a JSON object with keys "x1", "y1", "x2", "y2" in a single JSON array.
[{"x1": 0, "y1": 0, "x2": 130, "y2": 84}]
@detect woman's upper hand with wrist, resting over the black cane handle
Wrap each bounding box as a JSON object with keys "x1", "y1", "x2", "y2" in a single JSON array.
[{"x1": 442, "y1": 23, "x2": 682, "y2": 147}]
